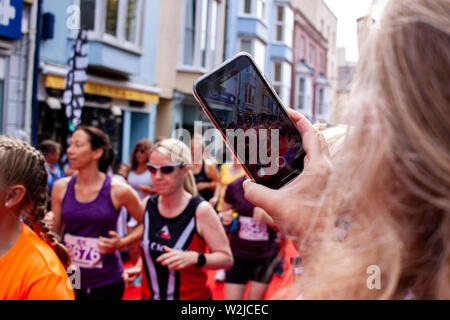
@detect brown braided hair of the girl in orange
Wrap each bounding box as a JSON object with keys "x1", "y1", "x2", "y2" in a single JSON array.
[{"x1": 0, "y1": 135, "x2": 71, "y2": 268}]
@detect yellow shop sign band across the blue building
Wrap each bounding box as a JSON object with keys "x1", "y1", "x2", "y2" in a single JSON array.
[{"x1": 45, "y1": 74, "x2": 159, "y2": 103}]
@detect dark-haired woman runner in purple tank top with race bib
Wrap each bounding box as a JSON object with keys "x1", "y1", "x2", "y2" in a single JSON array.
[{"x1": 46, "y1": 126, "x2": 144, "y2": 300}]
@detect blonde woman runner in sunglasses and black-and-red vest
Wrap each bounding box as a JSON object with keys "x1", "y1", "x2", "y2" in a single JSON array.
[{"x1": 125, "y1": 139, "x2": 233, "y2": 300}]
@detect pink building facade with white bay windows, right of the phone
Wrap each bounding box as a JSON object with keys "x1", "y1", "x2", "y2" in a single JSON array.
[{"x1": 291, "y1": 9, "x2": 330, "y2": 121}]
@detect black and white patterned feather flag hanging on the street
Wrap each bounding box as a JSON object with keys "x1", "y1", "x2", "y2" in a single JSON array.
[{"x1": 63, "y1": 29, "x2": 88, "y2": 133}]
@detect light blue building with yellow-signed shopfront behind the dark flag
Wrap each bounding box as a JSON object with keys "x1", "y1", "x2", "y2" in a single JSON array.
[{"x1": 37, "y1": 0, "x2": 160, "y2": 162}]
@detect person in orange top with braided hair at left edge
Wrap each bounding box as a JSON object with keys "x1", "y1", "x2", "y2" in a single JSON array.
[{"x1": 0, "y1": 136, "x2": 74, "y2": 300}]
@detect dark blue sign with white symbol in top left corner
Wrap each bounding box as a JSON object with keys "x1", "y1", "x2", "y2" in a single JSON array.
[{"x1": 0, "y1": 0, "x2": 23, "y2": 39}]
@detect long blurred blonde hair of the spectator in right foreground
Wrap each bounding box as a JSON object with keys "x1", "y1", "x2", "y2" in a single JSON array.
[{"x1": 284, "y1": 0, "x2": 450, "y2": 299}]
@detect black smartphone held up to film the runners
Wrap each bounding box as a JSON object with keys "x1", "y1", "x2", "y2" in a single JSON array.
[{"x1": 193, "y1": 52, "x2": 306, "y2": 189}]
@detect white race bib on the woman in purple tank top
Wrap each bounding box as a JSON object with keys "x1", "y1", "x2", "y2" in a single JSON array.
[{"x1": 64, "y1": 234, "x2": 103, "y2": 269}]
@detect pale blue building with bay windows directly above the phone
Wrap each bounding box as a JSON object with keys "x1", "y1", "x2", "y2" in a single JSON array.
[{"x1": 225, "y1": 0, "x2": 294, "y2": 107}]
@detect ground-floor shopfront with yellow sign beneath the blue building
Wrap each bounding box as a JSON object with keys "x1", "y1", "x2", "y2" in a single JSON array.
[{"x1": 37, "y1": 66, "x2": 159, "y2": 168}]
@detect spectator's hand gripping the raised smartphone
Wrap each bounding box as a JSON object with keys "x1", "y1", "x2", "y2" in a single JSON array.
[{"x1": 243, "y1": 109, "x2": 332, "y2": 237}]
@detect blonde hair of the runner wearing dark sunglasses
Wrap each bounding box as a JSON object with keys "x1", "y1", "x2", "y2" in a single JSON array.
[{"x1": 150, "y1": 139, "x2": 198, "y2": 196}]
